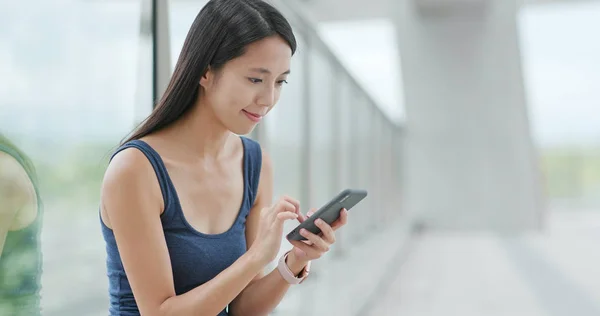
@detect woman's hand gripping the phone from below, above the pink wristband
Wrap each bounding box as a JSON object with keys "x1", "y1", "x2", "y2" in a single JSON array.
[{"x1": 288, "y1": 209, "x2": 348, "y2": 266}]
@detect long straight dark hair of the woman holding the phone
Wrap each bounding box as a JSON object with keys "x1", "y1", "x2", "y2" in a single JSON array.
[{"x1": 122, "y1": 0, "x2": 296, "y2": 143}]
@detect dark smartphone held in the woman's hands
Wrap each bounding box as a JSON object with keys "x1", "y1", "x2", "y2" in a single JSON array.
[{"x1": 286, "y1": 189, "x2": 367, "y2": 240}]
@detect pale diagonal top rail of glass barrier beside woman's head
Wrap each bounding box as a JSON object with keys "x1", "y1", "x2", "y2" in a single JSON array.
[{"x1": 269, "y1": 0, "x2": 403, "y2": 129}]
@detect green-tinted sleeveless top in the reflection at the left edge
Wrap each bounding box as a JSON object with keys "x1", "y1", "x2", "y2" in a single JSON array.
[{"x1": 0, "y1": 144, "x2": 42, "y2": 316}]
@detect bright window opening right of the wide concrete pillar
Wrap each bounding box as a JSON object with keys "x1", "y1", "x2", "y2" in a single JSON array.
[{"x1": 519, "y1": 1, "x2": 600, "y2": 210}]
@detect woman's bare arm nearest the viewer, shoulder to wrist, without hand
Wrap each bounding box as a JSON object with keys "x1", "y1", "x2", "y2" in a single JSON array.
[{"x1": 102, "y1": 149, "x2": 269, "y2": 316}]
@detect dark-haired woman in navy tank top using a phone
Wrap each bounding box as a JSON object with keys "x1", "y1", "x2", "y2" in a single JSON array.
[{"x1": 101, "y1": 0, "x2": 347, "y2": 316}]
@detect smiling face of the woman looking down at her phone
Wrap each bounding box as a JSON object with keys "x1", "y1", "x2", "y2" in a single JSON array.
[{"x1": 200, "y1": 36, "x2": 292, "y2": 135}]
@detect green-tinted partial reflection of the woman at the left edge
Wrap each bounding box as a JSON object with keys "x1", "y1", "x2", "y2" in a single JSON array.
[{"x1": 0, "y1": 134, "x2": 42, "y2": 316}]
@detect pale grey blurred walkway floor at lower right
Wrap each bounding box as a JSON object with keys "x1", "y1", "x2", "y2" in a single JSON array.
[{"x1": 368, "y1": 212, "x2": 600, "y2": 316}]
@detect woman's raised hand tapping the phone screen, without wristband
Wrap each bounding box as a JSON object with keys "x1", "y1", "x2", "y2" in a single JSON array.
[{"x1": 249, "y1": 196, "x2": 305, "y2": 265}]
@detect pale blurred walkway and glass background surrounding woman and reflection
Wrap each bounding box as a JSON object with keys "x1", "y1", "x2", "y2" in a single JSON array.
[{"x1": 0, "y1": 0, "x2": 600, "y2": 316}]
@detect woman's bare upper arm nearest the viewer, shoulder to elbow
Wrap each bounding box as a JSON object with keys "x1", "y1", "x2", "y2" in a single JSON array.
[{"x1": 101, "y1": 148, "x2": 175, "y2": 315}]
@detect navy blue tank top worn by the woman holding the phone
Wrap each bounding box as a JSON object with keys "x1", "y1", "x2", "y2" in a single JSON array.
[{"x1": 100, "y1": 137, "x2": 262, "y2": 316}]
